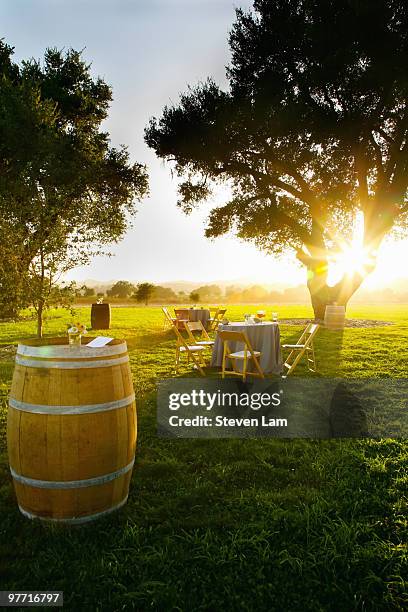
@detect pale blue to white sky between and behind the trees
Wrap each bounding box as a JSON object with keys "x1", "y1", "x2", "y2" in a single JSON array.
[{"x1": 0, "y1": 0, "x2": 408, "y2": 287}]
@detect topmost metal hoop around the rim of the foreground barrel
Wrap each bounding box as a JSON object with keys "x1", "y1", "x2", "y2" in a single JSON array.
[{"x1": 17, "y1": 341, "x2": 127, "y2": 359}]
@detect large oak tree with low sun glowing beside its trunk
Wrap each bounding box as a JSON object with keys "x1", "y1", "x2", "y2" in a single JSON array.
[{"x1": 145, "y1": 0, "x2": 408, "y2": 318}]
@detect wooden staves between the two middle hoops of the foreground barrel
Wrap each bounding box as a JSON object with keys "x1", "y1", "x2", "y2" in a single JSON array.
[{"x1": 9, "y1": 404, "x2": 136, "y2": 481}]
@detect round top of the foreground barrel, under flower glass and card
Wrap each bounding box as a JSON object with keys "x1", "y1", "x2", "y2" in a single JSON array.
[{"x1": 17, "y1": 336, "x2": 127, "y2": 359}]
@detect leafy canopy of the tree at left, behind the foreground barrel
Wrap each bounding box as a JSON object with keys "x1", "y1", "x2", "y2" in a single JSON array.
[{"x1": 0, "y1": 41, "x2": 147, "y2": 326}]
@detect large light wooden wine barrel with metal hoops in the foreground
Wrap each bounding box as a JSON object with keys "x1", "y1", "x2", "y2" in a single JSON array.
[{"x1": 7, "y1": 338, "x2": 136, "y2": 523}]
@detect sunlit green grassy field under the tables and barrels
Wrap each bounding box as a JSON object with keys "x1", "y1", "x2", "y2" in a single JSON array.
[{"x1": 0, "y1": 305, "x2": 408, "y2": 612}]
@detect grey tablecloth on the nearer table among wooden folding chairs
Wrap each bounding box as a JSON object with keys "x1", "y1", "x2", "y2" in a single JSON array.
[{"x1": 211, "y1": 321, "x2": 282, "y2": 374}]
